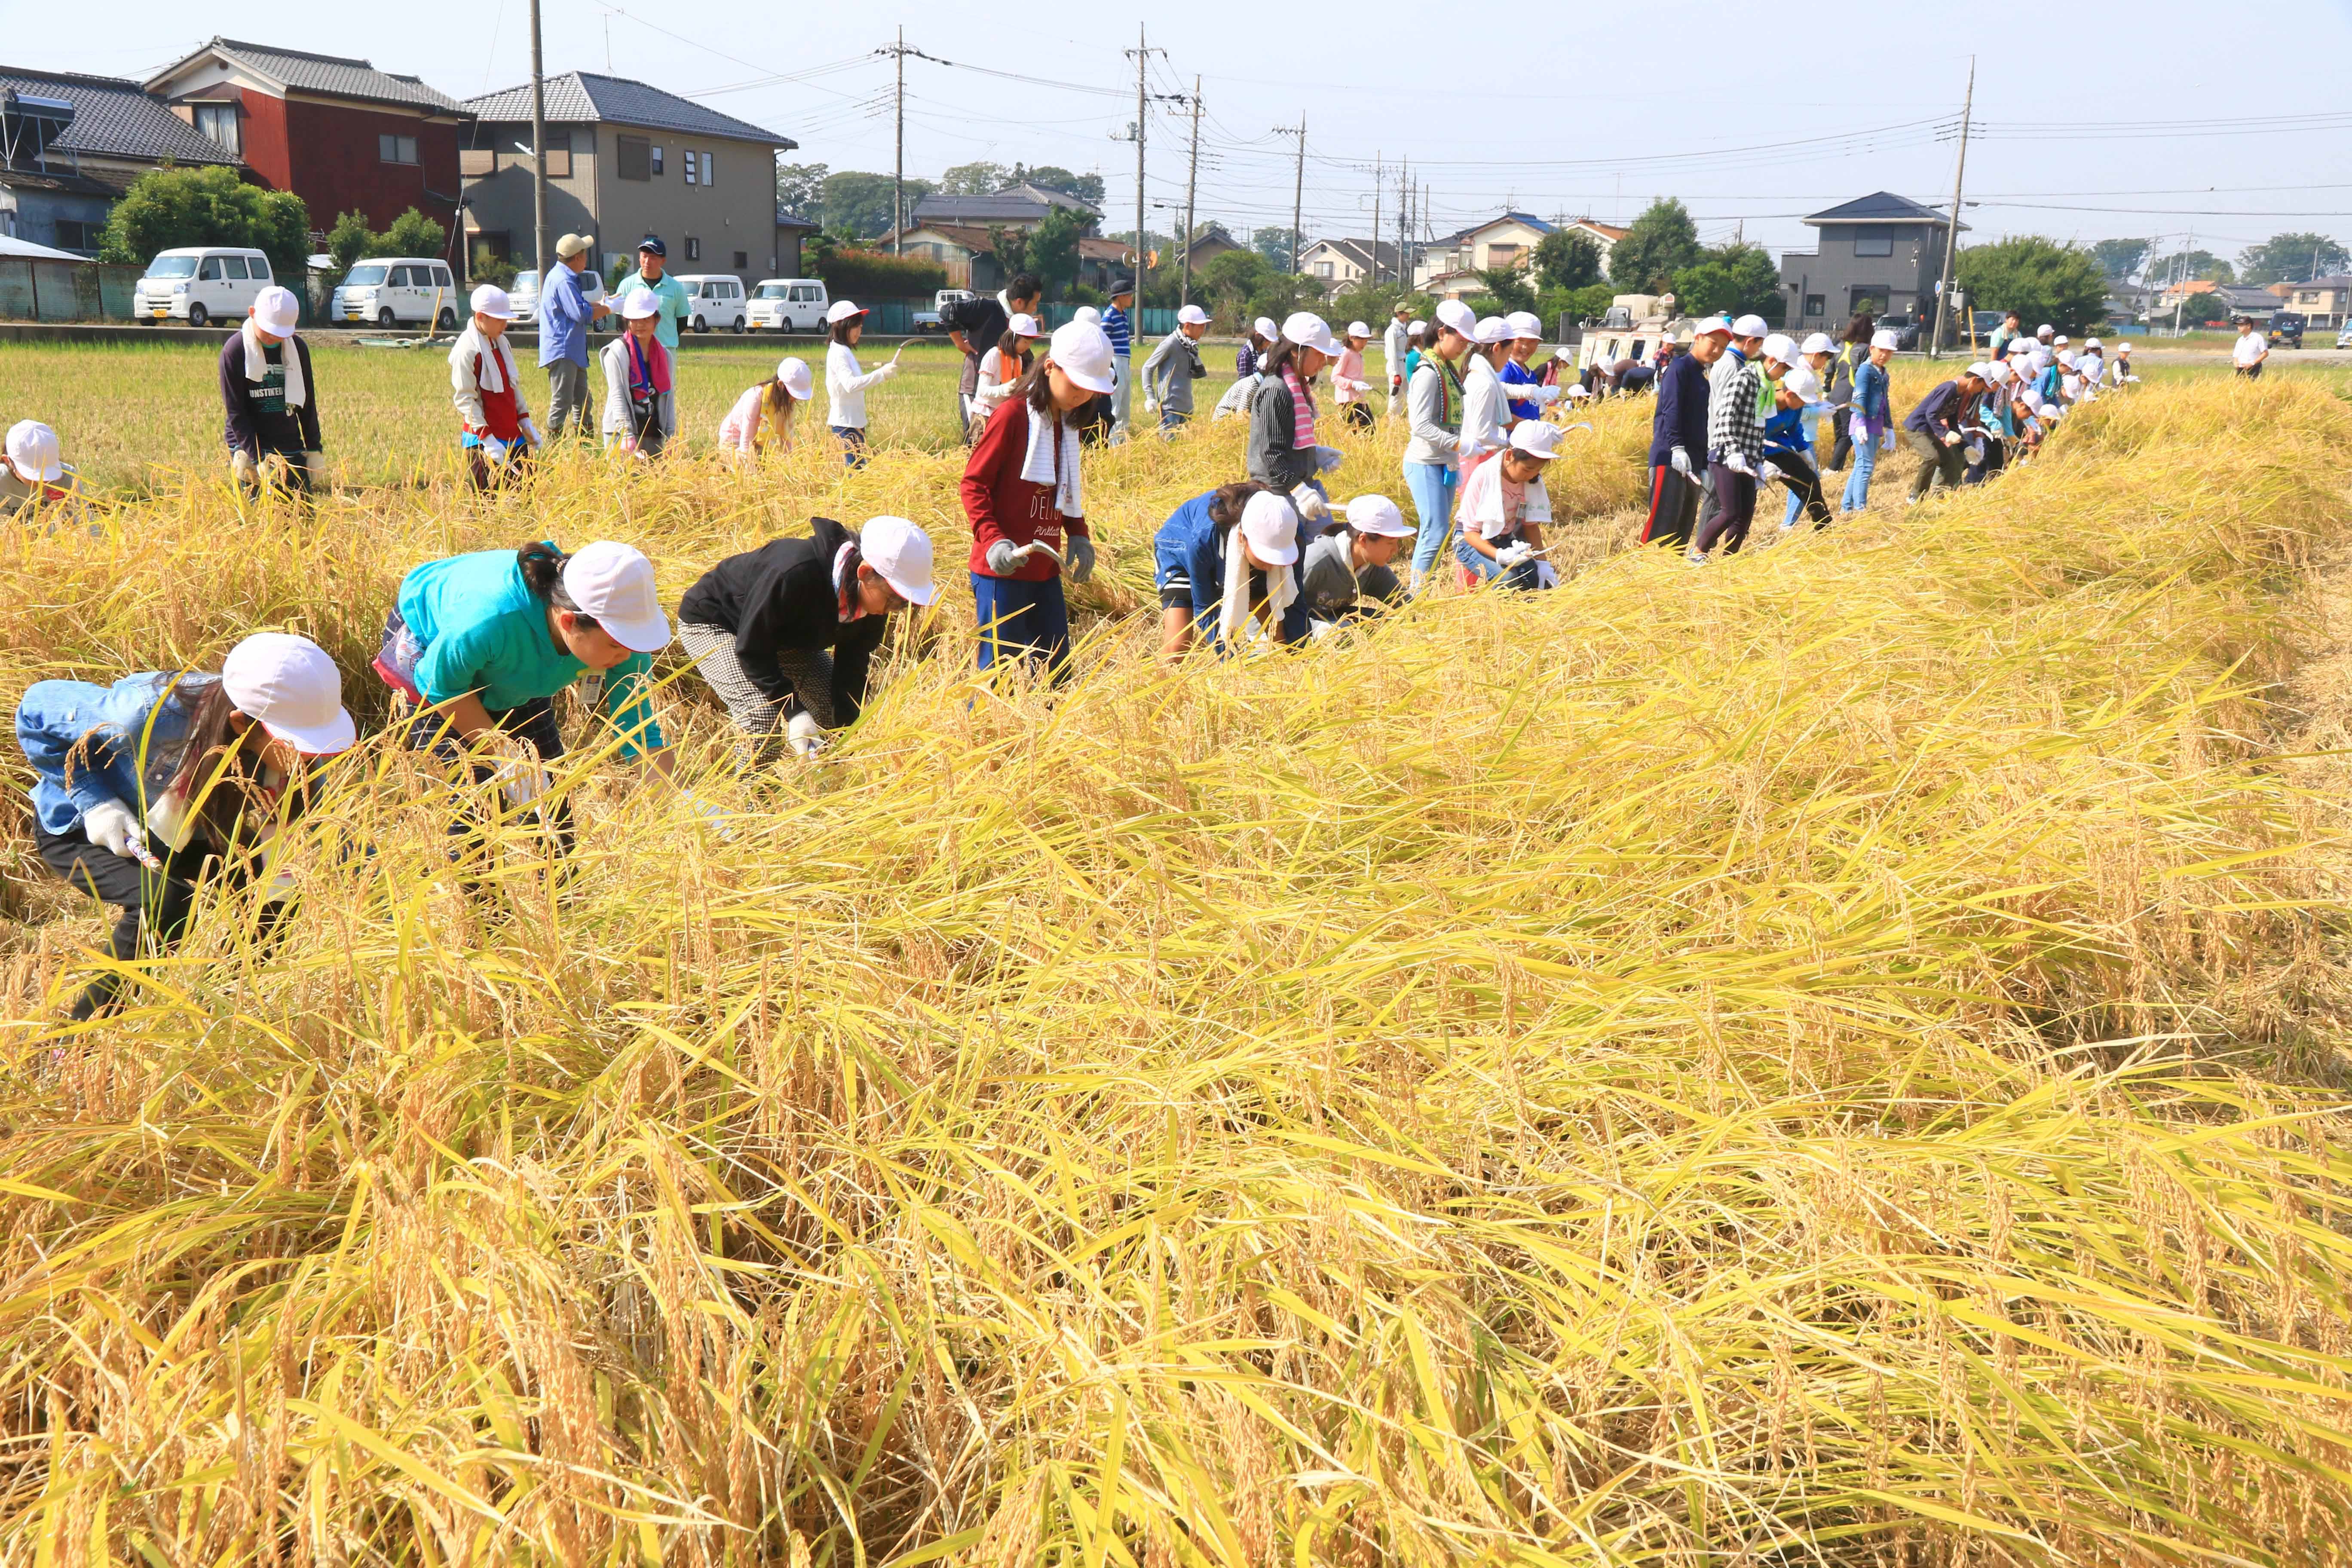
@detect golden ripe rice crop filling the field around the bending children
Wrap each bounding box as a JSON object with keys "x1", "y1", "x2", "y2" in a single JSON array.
[{"x1": 0, "y1": 383, "x2": 2352, "y2": 1568}]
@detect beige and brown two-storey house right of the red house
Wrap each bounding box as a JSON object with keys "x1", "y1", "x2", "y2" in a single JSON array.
[{"x1": 461, "y1": 70, "x2": 802, "y2": 289}]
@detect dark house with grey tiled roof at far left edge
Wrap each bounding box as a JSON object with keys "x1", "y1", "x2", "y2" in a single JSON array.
[{"x1": 0, "y1": 66, "x2": 240, "y2": 256}]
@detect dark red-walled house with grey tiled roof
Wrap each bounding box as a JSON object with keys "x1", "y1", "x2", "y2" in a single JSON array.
[{"x1": 146, "y1": 38, "x2": 470, "y2": 233}]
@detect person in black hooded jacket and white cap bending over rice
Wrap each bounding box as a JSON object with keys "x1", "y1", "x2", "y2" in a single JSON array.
[{"x1": 677, "y1": 517, "x2": 938, "y2": 764}]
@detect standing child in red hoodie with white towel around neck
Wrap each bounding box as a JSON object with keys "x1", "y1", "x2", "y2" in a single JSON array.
[{"x1": 965, "y1": 322, "x2": 1112, "y2": 682}]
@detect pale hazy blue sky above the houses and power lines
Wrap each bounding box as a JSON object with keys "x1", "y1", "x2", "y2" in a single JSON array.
[{"x1": 18, "y1": 0, "x2": 2352, "y2": 270}]
